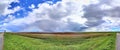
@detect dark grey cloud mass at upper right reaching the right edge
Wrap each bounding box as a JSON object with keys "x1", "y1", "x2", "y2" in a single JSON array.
[{"x1": 83, "y1": 0, "x2": 120, "y2": 29}]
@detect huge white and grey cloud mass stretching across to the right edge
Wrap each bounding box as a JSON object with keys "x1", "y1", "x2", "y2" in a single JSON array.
[{"x1": 1, "y1": 0, "x2": 120, "y2": 32}]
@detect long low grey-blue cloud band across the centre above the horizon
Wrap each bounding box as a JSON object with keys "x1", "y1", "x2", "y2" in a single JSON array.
[{"x1": 32, "y1": 20, "x2": 87, "y2": 32}]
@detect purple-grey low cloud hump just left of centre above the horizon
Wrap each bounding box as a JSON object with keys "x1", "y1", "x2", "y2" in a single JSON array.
[{"x1": 32, "y1": 20, "x2": 62, "y2": 32}]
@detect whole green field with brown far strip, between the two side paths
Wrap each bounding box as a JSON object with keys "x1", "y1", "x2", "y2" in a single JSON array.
[{"x1": 4, "y1": 32, "x2": 116, "y2": 50}]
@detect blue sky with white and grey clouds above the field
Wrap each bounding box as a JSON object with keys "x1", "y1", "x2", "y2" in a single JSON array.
[{"x1": 0, "y1": 0, "x2": 120, "y2": 32}]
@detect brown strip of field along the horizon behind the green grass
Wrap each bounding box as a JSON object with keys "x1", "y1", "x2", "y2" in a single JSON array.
[{"x1": 9, "y1": 32, "x2": 111, "y2": 38}]
